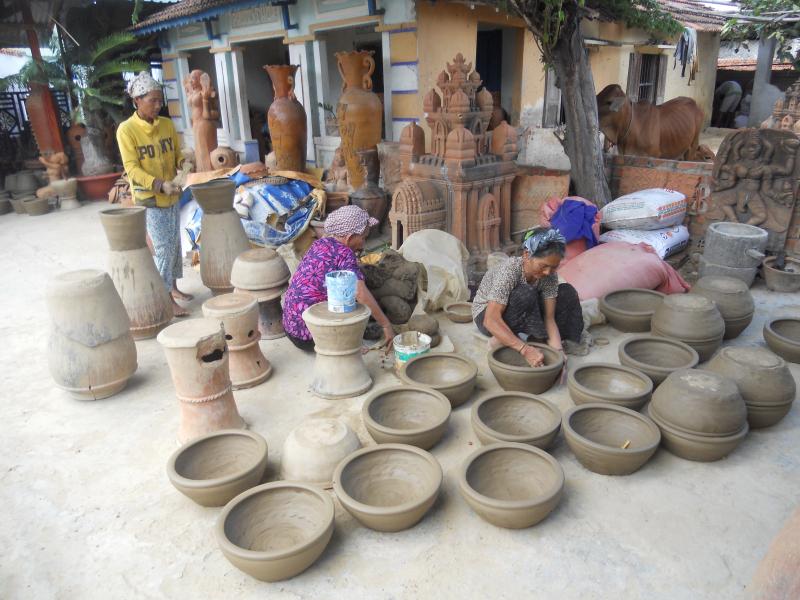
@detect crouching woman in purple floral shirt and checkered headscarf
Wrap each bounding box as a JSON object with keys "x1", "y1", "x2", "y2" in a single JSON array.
[{"x1": 283, "y1": 205, "x2": 394, "y2": 351}]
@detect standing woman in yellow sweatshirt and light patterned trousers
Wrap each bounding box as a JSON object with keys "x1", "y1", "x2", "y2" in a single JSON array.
[{"x1": 117, "y1": 71, "x2": 192, "y2": 317}]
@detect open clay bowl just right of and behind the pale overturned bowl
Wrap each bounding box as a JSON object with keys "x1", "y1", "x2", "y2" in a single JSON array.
[{"x1": 361, "y1": 385, "x2": 451, "y2": 450}]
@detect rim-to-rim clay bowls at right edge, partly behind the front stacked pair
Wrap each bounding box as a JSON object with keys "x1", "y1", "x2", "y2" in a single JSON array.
[{"x1": 705, "y1": 346, "x2": 797, "y2": 429}]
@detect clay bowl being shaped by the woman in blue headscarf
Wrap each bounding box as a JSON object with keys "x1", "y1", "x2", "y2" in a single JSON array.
[{"x1": 487, "y1": 343, "x2": 564, "y2": 394}]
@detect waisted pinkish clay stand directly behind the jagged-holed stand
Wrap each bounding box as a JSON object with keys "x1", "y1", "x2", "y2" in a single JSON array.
[{"x1": 203, "y1": 294, "x2": 272, "y2": 390}]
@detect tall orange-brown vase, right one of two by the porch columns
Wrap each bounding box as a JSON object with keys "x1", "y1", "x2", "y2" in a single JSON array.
[{"x1": 336, "y1": 50, "x2": 383, "y2": 189}]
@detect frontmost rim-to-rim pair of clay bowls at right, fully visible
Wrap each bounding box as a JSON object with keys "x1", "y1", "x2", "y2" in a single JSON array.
[{"x1": 647, "y1": 369, "x2": 749, "y2": 462}]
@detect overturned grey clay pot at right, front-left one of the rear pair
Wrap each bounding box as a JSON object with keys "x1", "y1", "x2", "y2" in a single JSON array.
[{"x1": 651, "y1": 294, "x2": 725, "y2": 362}]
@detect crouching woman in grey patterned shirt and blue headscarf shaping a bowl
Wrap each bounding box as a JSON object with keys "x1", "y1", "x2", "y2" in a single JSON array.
[{"x1": 472, "y1": 227, "x2": 583, "y2": 367}]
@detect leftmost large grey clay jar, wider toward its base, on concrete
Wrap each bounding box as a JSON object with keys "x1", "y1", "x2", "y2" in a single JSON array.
[{"x1": 47, "y1": 269, "x2": 137, "y2": 400}]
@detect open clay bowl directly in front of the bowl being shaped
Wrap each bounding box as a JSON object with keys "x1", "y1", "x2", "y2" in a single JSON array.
[{"x1": 470, "y1": 392, "x2": 561, "y2": 450}]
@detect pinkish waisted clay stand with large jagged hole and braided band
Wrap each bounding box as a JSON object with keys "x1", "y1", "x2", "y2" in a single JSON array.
[{"x1": 158, "y1": 319, "x2": 245, "y2": 443}]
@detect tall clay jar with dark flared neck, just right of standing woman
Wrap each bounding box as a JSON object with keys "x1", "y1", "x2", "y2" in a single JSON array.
[{"x1": 189, "y1": 179, "x2": 250, "y2": 294}]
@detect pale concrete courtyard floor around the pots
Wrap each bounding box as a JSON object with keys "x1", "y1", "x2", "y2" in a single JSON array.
[{"x1": 0, "y1": 203, "x2": 800, "y2": 600}]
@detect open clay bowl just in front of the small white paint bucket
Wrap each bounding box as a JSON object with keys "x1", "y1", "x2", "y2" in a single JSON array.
[{"x1": 398, "y1": 352, "x2": 478, "y2": 408}]
